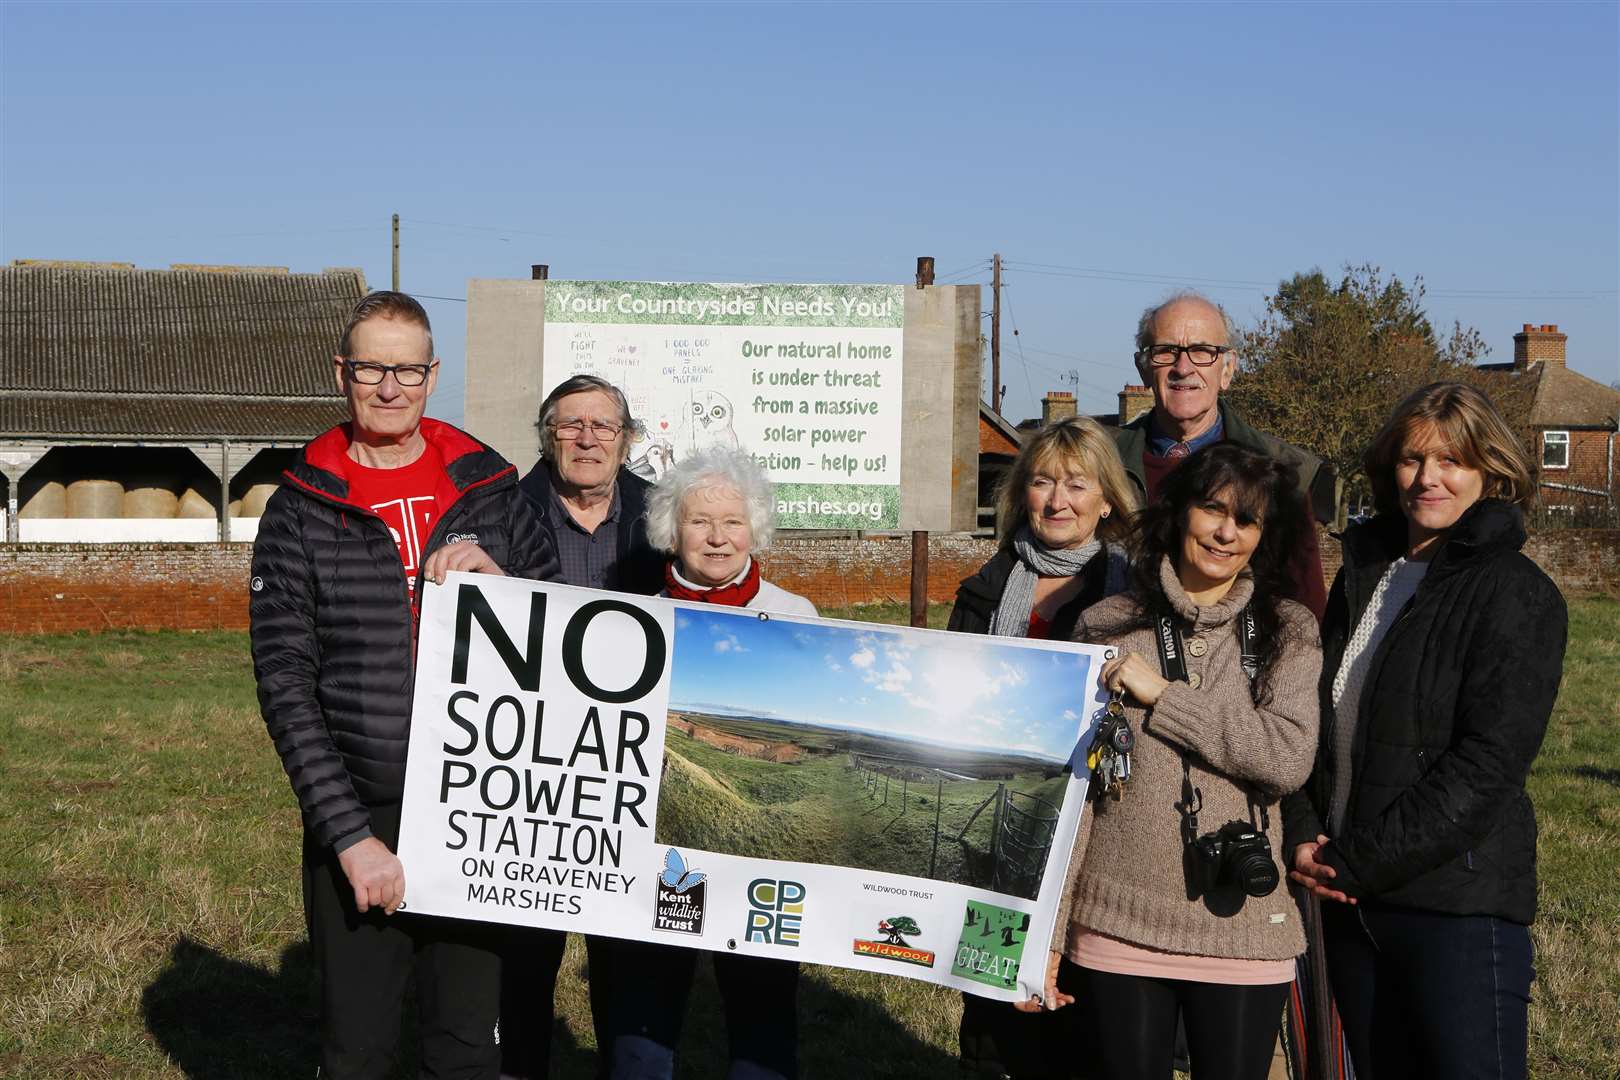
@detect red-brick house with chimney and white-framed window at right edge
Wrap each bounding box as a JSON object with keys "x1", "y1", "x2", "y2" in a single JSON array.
[{"x1": 1482, "y1": 322, "x2": 1620, "y2": 512}]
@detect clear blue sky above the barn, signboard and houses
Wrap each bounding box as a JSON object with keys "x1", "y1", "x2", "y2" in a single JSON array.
[{"x1": 0, "y1": 0, "x2": 1620, "y2": 419}]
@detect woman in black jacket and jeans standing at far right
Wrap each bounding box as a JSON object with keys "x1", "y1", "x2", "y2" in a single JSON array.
[{"x1": 1283, "y1": 382, "x2": 1567, "y2": 1080}]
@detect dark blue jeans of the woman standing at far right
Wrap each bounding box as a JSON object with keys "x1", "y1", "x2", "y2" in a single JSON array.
[{"x1": 1322, "y1": 902, "x2": 1534, "y2": 1080}]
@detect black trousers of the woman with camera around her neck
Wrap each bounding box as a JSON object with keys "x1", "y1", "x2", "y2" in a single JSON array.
[{"x1": 1058, "y1": 959, "x2": 1290, "y2": 1080}]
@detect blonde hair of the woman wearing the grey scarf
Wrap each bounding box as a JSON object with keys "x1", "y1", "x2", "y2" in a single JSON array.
[{"x1": 996, "y1": 416, "x2": 1136, "y2": 547}]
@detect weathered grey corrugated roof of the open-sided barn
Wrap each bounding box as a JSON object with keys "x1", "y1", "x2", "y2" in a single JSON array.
[{"x1": 0, "y1": 261, "x2": 366, "y2": 439}]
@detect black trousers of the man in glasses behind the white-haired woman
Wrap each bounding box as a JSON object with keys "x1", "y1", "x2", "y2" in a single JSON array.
[{"x1": 501, "y1": 926, "x2": 614, "y2": 1080}]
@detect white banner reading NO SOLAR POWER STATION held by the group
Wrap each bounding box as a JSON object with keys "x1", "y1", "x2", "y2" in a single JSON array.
[{"x1": 399, "y1": 573, "x2": 1110, "y2": 1001}]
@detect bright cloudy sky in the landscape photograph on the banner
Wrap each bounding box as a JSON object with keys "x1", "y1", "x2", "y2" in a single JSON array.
[{"x1": 669, "y1": 607, "x2": 1095, "y2": 761}]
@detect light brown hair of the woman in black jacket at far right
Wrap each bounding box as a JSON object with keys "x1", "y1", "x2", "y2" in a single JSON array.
[{"x1": 1361, "y1": 382, "x2": 1536, "y2": 513}]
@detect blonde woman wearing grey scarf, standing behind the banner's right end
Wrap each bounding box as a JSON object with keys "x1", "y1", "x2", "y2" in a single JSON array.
[{"x1": 949, "y1": 416, "x2": 1137, "y2": 1078}]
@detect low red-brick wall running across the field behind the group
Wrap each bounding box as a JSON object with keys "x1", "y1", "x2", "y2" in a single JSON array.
[{"x1": 0, "y1": 529, "x2": 1620, "y2": 635}]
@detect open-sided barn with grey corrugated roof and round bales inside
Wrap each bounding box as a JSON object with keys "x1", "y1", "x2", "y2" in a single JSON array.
[{"x1": 0, "y1": 259, "x2": 366, "y2": 542}]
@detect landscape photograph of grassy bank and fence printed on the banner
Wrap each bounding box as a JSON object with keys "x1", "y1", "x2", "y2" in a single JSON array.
[{"x1": 654, "y1": 607, "x2": 1095, "y2": 899}]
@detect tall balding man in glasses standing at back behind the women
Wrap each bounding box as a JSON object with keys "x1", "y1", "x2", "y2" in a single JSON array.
[{"x1": 1115, "y1": 291, "x2": 1335, "y2": 620}]
